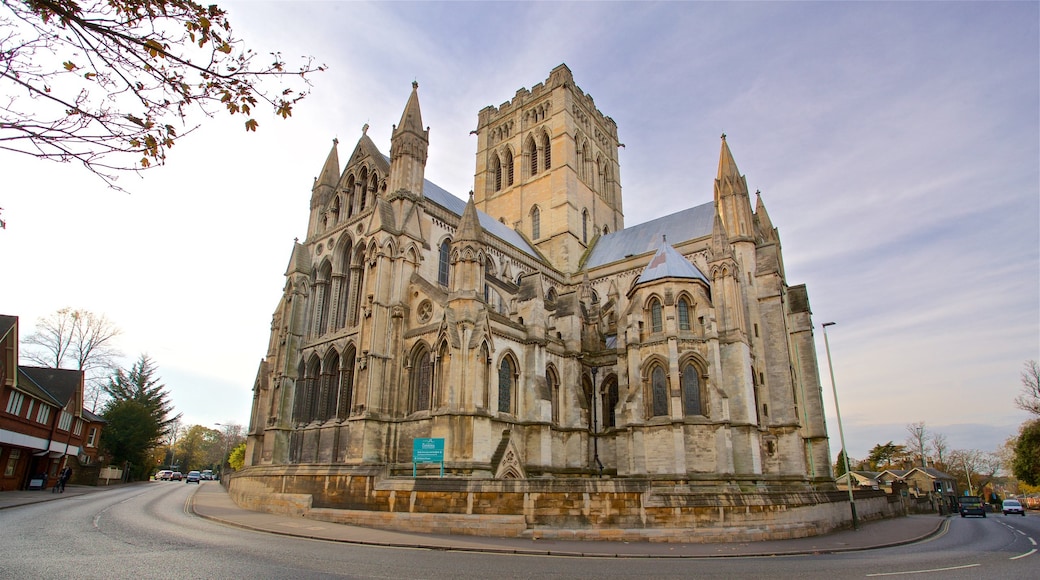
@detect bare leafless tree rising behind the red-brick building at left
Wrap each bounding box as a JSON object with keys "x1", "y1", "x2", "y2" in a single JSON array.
[{"x1": 20, "y1": 309, "x2": 123, "y2": 412}]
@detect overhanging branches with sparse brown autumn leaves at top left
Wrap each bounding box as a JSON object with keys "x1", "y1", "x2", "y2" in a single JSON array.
[{"x1": 0, "y1": 0, "x2": 324, "y2": 187}]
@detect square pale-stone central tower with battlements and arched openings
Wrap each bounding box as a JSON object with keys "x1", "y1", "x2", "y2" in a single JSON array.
[{"x1": 473, "y1": 64, "x2": 625, "y2": 273}]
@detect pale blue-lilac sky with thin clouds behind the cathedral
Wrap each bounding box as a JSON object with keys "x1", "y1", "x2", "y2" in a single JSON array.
[{"x1": 0, "y1": 1, "x2": 1040, "y2": 458}]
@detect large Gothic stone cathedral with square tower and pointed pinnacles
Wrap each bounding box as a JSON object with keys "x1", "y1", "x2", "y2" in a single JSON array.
[{"x1": 238, "y1": 65, "x2": 869, "y2": 540}]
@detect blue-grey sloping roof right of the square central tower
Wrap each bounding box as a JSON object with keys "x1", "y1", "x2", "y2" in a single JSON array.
[{"x1": 584, "y1": 202, "x2": 714, "y2": 270}]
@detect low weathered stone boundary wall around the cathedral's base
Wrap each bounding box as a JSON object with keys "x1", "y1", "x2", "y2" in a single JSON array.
[{"x1": 229, "y1": 466, "x2": 905, "y2": 542}]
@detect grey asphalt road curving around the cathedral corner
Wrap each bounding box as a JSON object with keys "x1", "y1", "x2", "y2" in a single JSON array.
[{"x1": 0, "y1": 482, "x2": 1040, "y2": 580}]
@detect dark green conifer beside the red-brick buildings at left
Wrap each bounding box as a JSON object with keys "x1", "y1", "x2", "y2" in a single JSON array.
[{"x1": 102, "y1": 354, "x2": 181, "y2": 475}]
